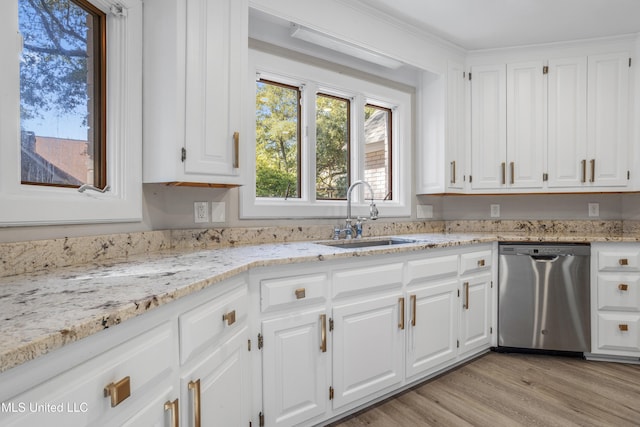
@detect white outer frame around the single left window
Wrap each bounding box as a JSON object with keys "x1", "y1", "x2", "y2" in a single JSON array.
[{"x1": 0, "y1": 0, "x2": 142, "y2": 227}]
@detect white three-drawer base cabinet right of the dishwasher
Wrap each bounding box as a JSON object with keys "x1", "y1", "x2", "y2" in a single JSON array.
[{"x1": 591, "y1": 243, "x2": 640, "y2": 360}]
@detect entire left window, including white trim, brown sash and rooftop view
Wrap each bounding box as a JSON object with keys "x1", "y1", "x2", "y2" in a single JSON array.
[{"x1": 0, "y1": 0, "x2": 143, "y2": 227}]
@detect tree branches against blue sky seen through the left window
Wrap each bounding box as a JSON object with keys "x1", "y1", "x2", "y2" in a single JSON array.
[{"x1": 18, "y1": 0, "x2": 91, "y2": 120}]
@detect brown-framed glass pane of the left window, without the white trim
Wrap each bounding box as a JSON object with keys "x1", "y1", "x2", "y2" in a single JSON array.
[{"x1": 18, "y1": 0, "x2": 106, "y2": 188}]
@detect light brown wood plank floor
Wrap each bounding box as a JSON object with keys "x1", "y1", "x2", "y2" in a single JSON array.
[{"x1": 332, "y1": 353, "x2": 640, "y2": 427}]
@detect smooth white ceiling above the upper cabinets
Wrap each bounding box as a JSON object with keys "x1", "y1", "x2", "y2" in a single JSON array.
[{"x1": 361, "y1": 0, "x2": 640, "y2": 50}]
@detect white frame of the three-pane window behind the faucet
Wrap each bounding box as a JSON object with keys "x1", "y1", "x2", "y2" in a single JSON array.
[{"x1": 240, "y1": 49, "x2": 412, "y2": 219}]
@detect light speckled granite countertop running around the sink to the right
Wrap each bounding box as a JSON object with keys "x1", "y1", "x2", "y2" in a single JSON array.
[{"x1": 0, "y1": 233, "x2": 638, "y2": 372}]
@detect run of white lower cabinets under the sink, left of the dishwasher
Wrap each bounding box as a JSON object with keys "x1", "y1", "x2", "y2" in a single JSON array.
[{"x1": 250, "y1": 244, "x2": 494, "y2": 427}]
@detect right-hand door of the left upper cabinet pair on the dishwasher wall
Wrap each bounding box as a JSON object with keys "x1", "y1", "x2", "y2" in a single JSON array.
[{"x1": 504, "y1": 61, "x2": 547, "y2": 188}]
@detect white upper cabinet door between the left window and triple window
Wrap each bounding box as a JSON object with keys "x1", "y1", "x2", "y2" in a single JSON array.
[{"x1": 185, "y1": 0, "x2": 247, "y2": 181}]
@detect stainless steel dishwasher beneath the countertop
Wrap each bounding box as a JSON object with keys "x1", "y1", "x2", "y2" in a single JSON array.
[{"x1": 497, "y1": 243, "x2": 591, "y2": 353}]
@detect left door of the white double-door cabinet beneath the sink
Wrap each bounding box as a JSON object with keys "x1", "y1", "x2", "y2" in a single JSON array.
[{"x1": 333, "y1": 293, "x2": 405, "y2": 409}]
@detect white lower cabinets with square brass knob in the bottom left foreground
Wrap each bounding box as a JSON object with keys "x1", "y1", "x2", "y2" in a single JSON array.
[{"x1": 0, "y1": 275, "x2": 251, "y2": 427}]
